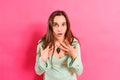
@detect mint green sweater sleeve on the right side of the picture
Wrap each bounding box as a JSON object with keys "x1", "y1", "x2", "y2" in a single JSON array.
[{"x1": 67, "y1": 39, "x2": 83, "y2": 75}]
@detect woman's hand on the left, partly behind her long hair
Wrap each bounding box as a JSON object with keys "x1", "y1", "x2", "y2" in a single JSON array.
[{"x1": 40, "y1": 46, "x2": 52, "y2": 62}]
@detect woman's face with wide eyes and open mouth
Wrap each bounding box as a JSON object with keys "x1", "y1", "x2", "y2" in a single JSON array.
[{"x1": 52, "y1": 15, "x2": 67, "y2": 40}]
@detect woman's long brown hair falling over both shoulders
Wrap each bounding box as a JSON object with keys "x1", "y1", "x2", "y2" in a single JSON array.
[{"x1": 42, "y1": 10, "x2": 74, "y2": 48}]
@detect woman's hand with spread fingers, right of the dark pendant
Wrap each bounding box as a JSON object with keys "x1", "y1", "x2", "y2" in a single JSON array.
[{"x1": 60, "y1": 41, "x2": 77, "y2": 60}]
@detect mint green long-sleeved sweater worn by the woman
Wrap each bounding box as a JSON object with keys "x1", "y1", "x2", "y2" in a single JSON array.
[{"x1": 35, "y1": 39, "x2": 83, "y2": 80}]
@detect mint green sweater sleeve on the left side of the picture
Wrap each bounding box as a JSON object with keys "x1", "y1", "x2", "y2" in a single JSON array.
[{"x1": 35, "y1": 41, "x2": 50, "y2": 75}]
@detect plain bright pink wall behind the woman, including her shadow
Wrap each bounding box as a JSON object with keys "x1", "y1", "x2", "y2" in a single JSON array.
[{"x1": 0, "y1": 0, "x2": 120, "y2": 80}]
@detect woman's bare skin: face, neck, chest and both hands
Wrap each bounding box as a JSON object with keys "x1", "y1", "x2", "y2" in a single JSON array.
[{"x1": 40, "y1": 16, "x2": 77, "y2": 62}]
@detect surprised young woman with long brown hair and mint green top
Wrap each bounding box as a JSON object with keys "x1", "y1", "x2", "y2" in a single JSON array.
[{"x1": 35, "y1": 10, "x2": 83, "y2": 80}]
